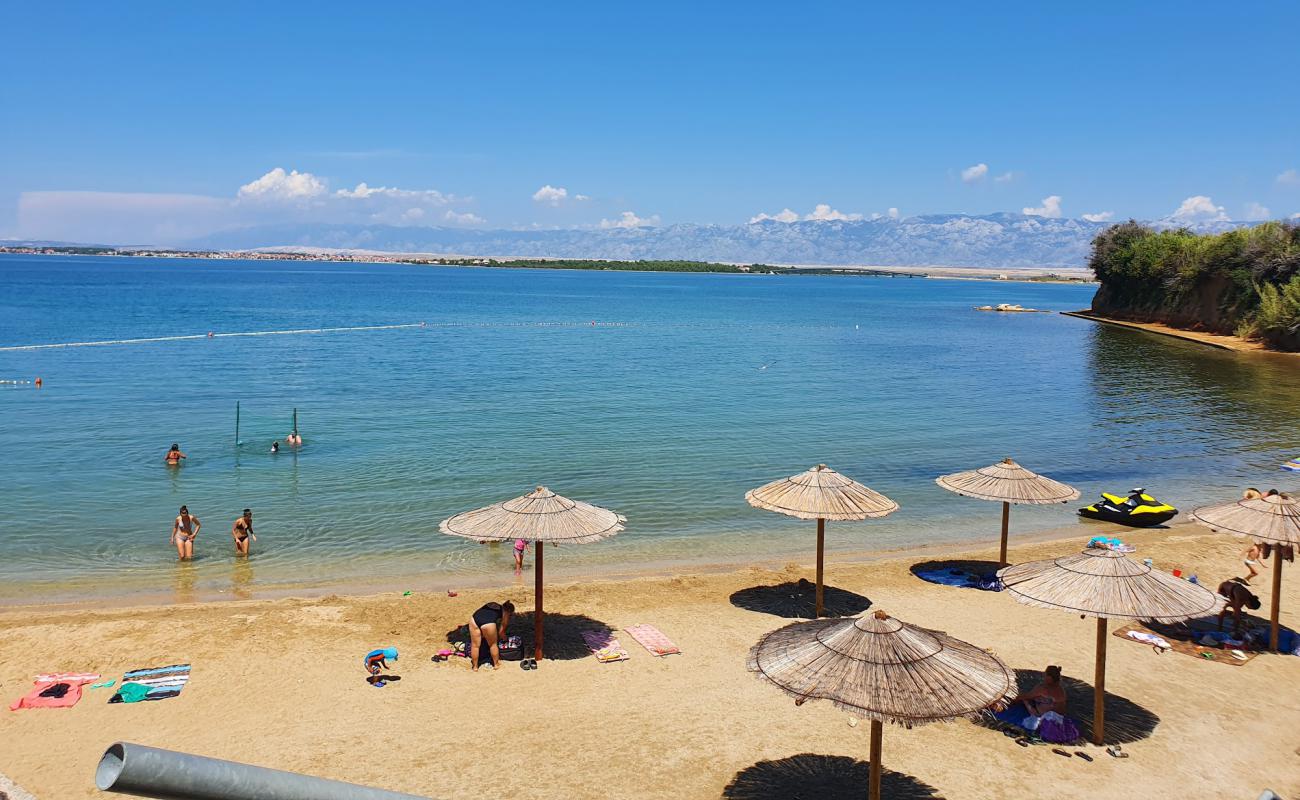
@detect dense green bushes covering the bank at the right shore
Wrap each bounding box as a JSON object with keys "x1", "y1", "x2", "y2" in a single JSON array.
[{"x1": 1088, "y1": 220, "x2": 1300, "y2": 350}]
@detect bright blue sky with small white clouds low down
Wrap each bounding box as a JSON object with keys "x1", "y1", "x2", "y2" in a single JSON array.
[{"x1": 0, "y1": 0, "x2": 1300, "y2": 243}]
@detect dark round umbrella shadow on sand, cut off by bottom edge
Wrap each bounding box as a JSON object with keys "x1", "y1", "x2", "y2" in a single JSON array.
[{"x1": 723, "y1": 753, "x2": 943, "y2": 800}]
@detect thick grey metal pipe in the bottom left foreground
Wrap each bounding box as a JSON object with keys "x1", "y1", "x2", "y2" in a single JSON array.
[{"x1": 95, "y1": 741, "x2": 428, "y2": 800}]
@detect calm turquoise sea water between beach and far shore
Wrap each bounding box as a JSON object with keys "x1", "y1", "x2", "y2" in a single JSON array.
[{"x1": 0, "y1": 256, "x2": 1300, "y2": 601}]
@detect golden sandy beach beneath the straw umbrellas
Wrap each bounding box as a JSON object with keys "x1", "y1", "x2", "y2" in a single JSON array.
[{"x1": 0, "y1": 524, "x2": 1300, "y2": 800}]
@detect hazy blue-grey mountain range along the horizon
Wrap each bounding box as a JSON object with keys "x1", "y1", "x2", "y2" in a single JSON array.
[{"x1": 187, "y1": 213, "x2": 1238, "y2": 267}]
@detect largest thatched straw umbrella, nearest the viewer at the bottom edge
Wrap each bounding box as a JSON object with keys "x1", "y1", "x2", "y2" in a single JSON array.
[{"x1": 748, "y1": 611, "x2": 1015, "y2": 800}]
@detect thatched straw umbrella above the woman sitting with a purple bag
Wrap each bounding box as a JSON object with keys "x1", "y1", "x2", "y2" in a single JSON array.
[{"x1": 997, "y1": 548, "x2": 1223, "y2": 744}]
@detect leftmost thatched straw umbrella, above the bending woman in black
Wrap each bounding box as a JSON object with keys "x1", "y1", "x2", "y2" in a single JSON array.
[{"x1": 438, "y1": 487, "x2": 628, "y2": 658}]
